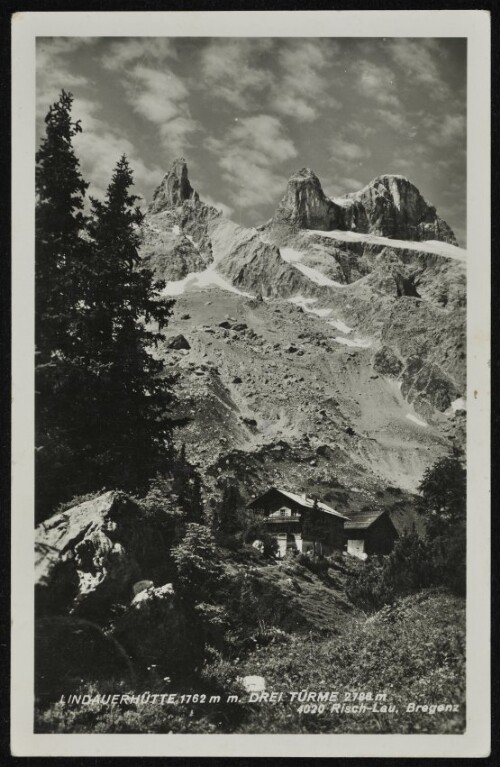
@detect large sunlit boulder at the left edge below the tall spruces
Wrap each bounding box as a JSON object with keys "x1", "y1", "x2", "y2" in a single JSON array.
[{"x1": 36, "y1": 492, "x2": 172, "y2": 620}]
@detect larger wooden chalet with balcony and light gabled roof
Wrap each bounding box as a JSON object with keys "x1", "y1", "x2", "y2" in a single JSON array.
[{"x1": 248, "y1": 487, "x2": 347, "y2": 559}]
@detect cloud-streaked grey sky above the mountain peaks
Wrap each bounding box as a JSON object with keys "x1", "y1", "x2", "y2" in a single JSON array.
[{"x1": 37, "y1": 37, "x2": 467, "y2": 246}]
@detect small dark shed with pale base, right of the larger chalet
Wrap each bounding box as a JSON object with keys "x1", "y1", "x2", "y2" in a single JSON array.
[{"x1": 344, "y1": 510, "x2": 399, "y2": 559}]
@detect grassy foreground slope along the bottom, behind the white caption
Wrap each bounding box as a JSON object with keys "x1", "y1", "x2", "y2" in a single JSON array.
[{"x1": 37, "y1": 591, "x2": 465, "y2": 733}]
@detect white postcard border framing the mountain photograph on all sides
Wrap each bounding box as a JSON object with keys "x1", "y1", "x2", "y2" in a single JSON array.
[{"x1": 11, "y1": 10, "x2": 490, "y2": 758}]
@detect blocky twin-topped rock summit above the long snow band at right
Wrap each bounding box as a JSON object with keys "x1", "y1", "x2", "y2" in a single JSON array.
[{"x1": 271, "y1": 168, "x2": 457, "y2": 245}]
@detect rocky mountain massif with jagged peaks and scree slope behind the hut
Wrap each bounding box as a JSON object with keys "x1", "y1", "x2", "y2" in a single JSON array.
[{"x1": 137, "y1": 160, "x2": 466, "y2": 498}]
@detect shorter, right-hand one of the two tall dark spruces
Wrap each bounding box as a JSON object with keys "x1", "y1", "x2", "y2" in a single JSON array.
[{"x1": 84, "y1": 156, "x2": 177, "y2": 488}]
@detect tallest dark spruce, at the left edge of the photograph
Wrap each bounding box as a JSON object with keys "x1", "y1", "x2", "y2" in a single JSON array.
[{"x1": 35, "y1": 91, "x2": 89, "y2": 519}]
